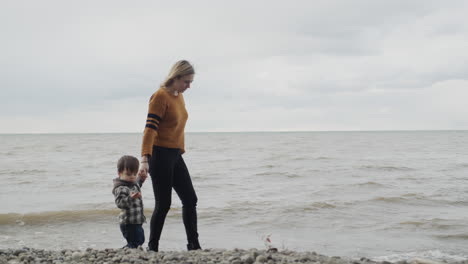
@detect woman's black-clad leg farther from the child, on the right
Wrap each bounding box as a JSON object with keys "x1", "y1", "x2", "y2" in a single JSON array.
[{"x1": 173, "y1": 156, "x2": 200, "y2": 250}]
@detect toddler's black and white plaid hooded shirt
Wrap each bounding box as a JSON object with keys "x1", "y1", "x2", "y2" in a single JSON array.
[{"x1": 112, "y1": 178, "x2": 146, "y2": 224}]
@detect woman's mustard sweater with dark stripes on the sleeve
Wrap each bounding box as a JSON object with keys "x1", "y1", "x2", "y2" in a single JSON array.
[{"x1": 141, "y1": 88, "x2": 188, "y2": 156}]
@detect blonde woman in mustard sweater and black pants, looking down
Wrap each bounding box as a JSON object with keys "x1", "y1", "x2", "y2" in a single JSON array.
[{"x1": 139, "y1": 60, "x2": 201, "y2": 251}]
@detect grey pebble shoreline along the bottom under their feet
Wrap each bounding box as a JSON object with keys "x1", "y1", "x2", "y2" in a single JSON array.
[{"x1": 0, "y1": 248, "x2": 468, "y2": 264}]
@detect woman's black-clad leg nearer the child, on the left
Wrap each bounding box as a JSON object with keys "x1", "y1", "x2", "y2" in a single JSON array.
[{"x1": 148, "y1": 147, "x2": 178, "y2": 251}]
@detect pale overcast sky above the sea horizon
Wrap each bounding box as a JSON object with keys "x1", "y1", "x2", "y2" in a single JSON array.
[{"x1": 0, "y1": 0, "x2": 468, "y2": 133}]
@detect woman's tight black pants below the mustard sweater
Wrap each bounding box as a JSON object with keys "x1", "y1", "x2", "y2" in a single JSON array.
[{"x1": 148, "y1": 146, "x2": 198, "y2": 250}]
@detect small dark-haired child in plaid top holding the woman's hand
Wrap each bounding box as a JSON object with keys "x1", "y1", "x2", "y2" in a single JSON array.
[{"x1": 112, "y1": 156, "x2": 147, "y2": 248}]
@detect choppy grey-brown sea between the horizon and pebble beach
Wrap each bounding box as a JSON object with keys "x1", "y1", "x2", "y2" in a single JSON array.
[{"x1": 0, "y1": 131, "x2": 468, "y2": 261}]
